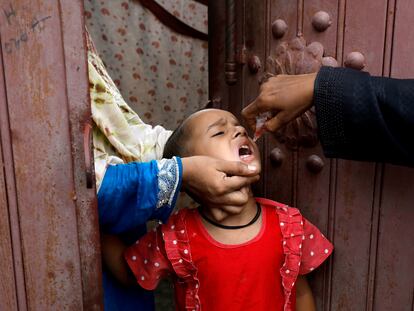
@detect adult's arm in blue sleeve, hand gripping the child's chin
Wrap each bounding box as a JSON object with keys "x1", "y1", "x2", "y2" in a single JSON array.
[{"x1": 98, "y1": 156, "x2": 259, "y2": 234}]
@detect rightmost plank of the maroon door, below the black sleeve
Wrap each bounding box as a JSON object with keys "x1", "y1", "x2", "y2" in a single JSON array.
[{"x1": 373, "y1": 165, "x2": 414, "y2": 311}]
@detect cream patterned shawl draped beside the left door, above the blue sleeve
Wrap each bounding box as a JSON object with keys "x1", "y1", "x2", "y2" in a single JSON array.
[{"x1": 87, "y1": 34, "x2": 171, "y2": 191}]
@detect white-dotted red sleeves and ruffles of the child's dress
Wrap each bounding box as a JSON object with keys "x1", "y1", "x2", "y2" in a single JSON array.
[{"x1": 125, "y1": 199, "x2": 333, "y2": 310}]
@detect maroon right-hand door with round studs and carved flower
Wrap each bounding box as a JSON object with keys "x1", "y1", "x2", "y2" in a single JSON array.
[{"x1": 209, "y1": 0, "x2": 414, "y2": 311}]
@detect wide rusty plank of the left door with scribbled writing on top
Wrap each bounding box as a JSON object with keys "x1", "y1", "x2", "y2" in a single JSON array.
[{"x1": 0, "y1": 0, "x2": 83, "y2": 310}]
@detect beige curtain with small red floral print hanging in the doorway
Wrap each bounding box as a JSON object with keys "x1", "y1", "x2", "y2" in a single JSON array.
[{"x1": 84, "y1": 0, "x2": 208, "y2": 129}]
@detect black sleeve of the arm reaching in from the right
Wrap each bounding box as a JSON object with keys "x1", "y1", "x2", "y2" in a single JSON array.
[{"x1": 314, "y1": 67, "x2": 414, "y2": 166}]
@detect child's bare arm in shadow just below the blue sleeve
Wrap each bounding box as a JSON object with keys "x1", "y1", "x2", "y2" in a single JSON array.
[{"x1": 101, "y1": 234, "x2": 137, "y2": 285}]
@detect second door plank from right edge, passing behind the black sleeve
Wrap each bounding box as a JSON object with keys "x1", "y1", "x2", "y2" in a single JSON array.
[{"x1": 331, "y1": 0, "x2": 387, "y2": 310}]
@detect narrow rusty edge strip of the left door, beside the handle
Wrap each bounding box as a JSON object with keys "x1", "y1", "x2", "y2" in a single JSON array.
[{"x1": 60, "y1": 0, "x2": 103, "y2": 310}]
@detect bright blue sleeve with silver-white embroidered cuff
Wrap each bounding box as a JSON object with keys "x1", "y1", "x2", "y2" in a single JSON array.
[{"x1": 98, "y1": 158, "x2": 182, "y2": 234}]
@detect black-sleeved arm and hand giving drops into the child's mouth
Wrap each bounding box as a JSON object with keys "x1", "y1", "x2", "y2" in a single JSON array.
[{"x1": 243, "y1": 67, "x2": 414, "y2": 166}]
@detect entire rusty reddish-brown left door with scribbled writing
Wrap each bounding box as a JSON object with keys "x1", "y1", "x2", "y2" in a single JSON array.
[{"x1": 0, "y1": 0, "x2": 102, "y2": 310}]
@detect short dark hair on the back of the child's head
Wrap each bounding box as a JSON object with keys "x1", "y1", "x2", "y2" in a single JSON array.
[{"x1": 162, "y1": 120, "x2": 190, "y2": 159}]
